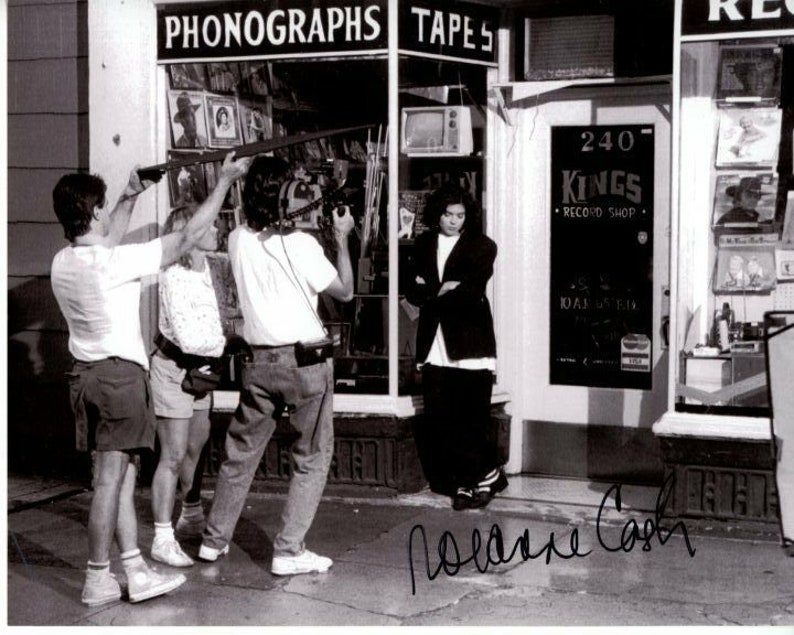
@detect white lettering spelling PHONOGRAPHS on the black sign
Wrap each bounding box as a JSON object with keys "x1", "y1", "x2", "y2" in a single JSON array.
[{"x1": 163, "y1": 5, "x2": 380, "y2": 49}]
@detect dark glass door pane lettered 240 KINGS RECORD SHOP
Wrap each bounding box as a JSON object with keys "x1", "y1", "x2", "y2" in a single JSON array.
[{"x1": 549, "y1": 125, "x2": 654, "y2": 389}]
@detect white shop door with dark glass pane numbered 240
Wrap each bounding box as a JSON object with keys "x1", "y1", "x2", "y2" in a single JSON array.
[{"x1": 496, "y1": 81, "x2": 671, "y2": 481}]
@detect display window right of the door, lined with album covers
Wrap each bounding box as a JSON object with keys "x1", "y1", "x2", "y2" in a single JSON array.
[{"x1": 673, "y1": 13, "x2": 794, "y2": 417}]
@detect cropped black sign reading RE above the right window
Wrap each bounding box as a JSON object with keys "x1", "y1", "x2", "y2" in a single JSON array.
[{"x1": 681, "y1": 0, "x2": 794, "y2": 38}]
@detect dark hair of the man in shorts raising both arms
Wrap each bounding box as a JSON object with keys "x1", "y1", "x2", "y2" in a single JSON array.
[{"x1": 52, "y1": 172, "x2": 107, "y2": 242}]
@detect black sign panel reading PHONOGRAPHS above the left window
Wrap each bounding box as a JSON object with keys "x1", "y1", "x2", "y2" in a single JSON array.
[{"x1": 157, "y1": 0, "x2": 387, "y2": 61}]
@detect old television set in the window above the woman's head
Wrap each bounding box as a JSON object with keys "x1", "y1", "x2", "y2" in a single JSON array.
[{"x1": 400, "y1": 106, "x2": 474, "y2": 157}]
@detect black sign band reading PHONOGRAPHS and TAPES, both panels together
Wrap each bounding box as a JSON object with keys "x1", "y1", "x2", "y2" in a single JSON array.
[{"x1": 157, "y1": 0, "x2": 499, "y2": 65}]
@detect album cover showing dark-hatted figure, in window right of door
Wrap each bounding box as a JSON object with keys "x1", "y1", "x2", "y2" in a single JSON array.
[{"x1": 712, "y1": 172, "x2": 777, "y2": 228}]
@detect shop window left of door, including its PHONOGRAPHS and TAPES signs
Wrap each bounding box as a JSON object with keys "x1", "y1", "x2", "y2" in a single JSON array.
[{"x1": 153, "y1": 0, "x2": 498, "y2": 411}]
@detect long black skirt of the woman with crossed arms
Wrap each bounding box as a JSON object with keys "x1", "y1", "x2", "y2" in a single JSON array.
[{"x1": 414, "y1": 364, "x2": 499, "y2": 495}]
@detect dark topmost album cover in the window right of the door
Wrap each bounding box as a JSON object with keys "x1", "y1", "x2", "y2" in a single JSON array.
[{"x1": 717, "y1": 45, "x2": 782, "y2": 104}]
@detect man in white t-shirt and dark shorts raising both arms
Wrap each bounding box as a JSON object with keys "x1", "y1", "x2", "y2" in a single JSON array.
[{"x1": 51, "y1": 152, "x2": 251, "y2": 606}]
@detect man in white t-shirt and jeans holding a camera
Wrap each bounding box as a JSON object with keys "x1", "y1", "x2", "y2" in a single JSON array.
[{"x1": 199, "y1": 157, "x2": 353, "y2": 575}]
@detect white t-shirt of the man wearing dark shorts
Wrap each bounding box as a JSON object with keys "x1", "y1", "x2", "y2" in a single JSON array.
[{"x1": 51, "y1": 238, "x2": 163, "y2": 368}]
